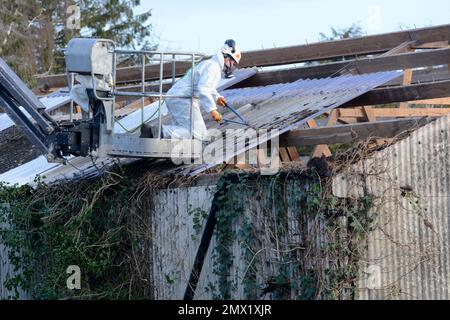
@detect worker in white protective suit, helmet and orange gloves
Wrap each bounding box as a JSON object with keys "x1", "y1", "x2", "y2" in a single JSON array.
[{"x1": 163, "y1": 40, "x2": 241, "y2": 140}]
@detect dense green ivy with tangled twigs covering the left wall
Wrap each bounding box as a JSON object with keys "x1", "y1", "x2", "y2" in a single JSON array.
[{"x1": 0, "y1": 162, "x2": 163, "y2": 299}]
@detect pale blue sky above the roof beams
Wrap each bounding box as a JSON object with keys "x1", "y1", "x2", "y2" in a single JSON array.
[{"x1": 137, "y1": 0, "x2": 450, "y2": 54}]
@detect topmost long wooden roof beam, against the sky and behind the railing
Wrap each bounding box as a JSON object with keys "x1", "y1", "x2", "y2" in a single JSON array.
[{"x1": 37, "y1": 24, "x2": 450, "y2": 88}]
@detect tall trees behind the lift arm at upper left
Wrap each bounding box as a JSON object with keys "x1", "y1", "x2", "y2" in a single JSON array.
[{"x1": 0, "y1": 0, "x2": 154, "y2": 84}]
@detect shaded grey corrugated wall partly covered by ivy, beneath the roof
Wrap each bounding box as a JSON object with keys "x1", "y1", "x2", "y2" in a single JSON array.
[{"x1": 153, "y1": 180, "x2": 338, "y2": 299}]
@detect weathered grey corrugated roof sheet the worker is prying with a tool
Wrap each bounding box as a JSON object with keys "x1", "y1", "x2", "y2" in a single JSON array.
[{"x1": 183, "y1": 71, "x2": 402, "y2": 175}]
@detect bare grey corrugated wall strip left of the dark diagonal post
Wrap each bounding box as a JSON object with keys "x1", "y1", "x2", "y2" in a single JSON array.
[{"x1": 153, "y1": 187, "x2": 217, "y2": 299}]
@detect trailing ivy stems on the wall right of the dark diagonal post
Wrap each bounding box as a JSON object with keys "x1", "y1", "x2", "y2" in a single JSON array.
[{"x1": 209, "y1": 171, "x2": 374, "y2": 300}]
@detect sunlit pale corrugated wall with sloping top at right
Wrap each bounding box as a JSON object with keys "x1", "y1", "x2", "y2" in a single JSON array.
[{"x1": 333, "y1": 117, "x2": 450, "y2": 299}]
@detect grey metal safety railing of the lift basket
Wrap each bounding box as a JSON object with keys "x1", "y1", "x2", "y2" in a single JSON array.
[{"x1": 113, "y1": 50, "x2": 204, "y2": 139}]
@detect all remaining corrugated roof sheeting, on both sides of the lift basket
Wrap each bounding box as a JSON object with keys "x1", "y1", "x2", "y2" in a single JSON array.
[{"x1": 0, "y1": 69, "x2": 402, "y2": 184}]
